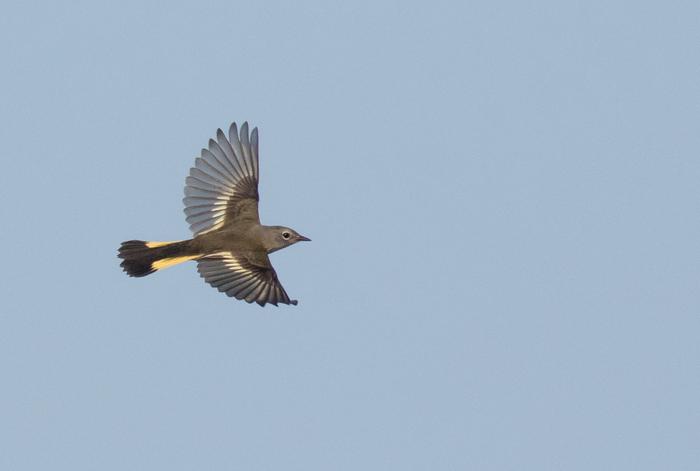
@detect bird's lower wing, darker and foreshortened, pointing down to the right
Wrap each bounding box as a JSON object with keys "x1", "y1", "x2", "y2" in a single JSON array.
[{"x1": 197, "y1": 252, "x2": 297, "y2": 306}]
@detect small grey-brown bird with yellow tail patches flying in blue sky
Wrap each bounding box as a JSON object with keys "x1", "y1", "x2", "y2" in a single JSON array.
[{"x1": 119, "y1": 123, "x2": 310, "y2": 306}]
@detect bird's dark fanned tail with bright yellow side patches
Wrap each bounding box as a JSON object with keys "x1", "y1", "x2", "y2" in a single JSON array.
[{"x1": 119, "y1": 240, "x2": 200, "y2": 276}]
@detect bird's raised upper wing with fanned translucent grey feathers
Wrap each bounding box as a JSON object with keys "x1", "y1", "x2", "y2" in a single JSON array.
[{"x1": 183, "y1": 123, "x2": 260, "y2": 235}]
